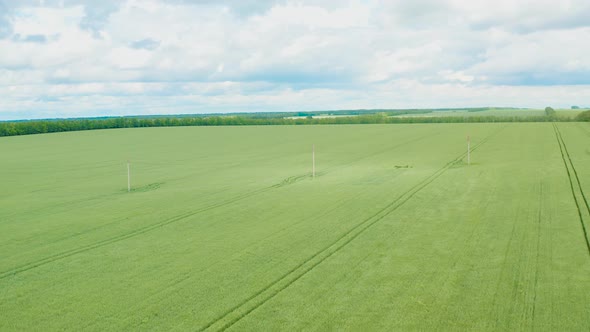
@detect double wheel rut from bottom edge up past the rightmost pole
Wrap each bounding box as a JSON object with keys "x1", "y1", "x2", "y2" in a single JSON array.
[{"x1": 199, "y1": 127, "x2": 504, "y2": 331}]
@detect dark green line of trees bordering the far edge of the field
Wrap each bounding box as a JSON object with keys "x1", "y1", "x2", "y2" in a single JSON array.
[{"x1": 0, "y1": 114, "x2": 587, "y2": 136}]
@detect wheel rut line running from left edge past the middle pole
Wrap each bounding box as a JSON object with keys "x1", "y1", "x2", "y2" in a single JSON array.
[{"x1": 0, "y1": 133, "x2": 444, "y2": 280}]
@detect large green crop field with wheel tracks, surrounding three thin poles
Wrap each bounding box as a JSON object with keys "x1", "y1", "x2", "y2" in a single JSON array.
[{"x1": 0, "y1": 123, "x2": 590, "y2": 331}]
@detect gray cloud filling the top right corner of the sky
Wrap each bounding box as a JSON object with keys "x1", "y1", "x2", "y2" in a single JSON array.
[{"x1": 377, "y1": 0, "x2": 590, "y2": 34}]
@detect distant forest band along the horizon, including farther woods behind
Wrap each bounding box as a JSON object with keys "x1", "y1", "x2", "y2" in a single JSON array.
[{"x1": 0, "y1": 108, "x2": 590, "y2": 136}]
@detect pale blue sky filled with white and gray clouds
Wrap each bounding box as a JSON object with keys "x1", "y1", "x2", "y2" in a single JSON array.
[{"x1": 0, "y1": 0, "x2": 590, "y2": 120}]
